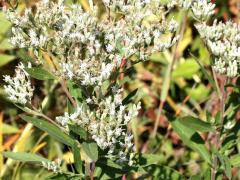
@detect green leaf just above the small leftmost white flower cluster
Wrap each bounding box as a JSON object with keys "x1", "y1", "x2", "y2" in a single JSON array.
[{"x1": 25, "y1": 67, "x2": 55, "y2": 80}]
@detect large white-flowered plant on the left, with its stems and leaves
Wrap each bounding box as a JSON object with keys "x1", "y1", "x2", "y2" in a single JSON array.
[{"x1": 1, "y1": 0, "x2": 178, "y2": 177}]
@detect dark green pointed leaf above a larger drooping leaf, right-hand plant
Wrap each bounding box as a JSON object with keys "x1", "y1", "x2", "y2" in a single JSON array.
[{"x1": 179, "y1": 116, "x2": 215, "y2": 132}]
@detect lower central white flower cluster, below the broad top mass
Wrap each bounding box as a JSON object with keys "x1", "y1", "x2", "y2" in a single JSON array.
[{"x1": 56, "y1": 90, "x2": 140, "y2": 165}]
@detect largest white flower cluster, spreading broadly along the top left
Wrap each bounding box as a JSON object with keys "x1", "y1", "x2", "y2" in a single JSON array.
[{"x1": 6, "y1": 0, "x2": 178, "y2": 85}]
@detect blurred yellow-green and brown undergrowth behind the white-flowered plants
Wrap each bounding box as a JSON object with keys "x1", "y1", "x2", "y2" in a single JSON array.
[{"x1": 0, "y1": 0, "x2": 240, "y2": 180}]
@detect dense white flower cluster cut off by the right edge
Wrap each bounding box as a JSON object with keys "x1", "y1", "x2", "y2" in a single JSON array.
[{"x1": 196, "y1": 21, "x2": 240, "y2": 77}]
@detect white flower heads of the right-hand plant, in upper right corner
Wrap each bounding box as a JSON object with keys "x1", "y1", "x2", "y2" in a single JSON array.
[{"x1": 169, "y1": 0, "x2": 240, "y2": 77}]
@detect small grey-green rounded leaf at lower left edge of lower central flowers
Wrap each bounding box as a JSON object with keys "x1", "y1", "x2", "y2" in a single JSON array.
[{"x1": 82, "y1": 142, "x2": 98, "y2": 162}]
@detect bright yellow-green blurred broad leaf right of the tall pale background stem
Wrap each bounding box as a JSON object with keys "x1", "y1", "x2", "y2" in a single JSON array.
[{"x1": 172, "y1": 59, "x2": 200, "y2": 79}]
